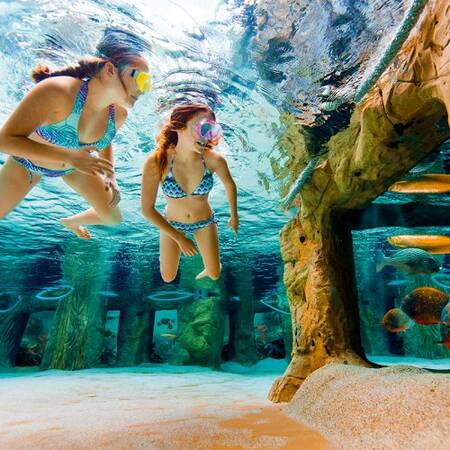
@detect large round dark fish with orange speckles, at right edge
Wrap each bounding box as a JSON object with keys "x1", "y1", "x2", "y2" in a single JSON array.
[{"x1": 400, "y1": 287, "x2": 450, "y2": 325}]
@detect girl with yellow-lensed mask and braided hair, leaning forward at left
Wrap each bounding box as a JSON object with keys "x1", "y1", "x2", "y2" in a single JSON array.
[{"x1": 0, "y1": 29, "x2": 150, "y2": 239}]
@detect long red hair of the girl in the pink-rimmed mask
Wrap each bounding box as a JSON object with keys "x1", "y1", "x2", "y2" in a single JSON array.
[{"x1": 155, "y1": 103, "x2": 216, "y2": 179}]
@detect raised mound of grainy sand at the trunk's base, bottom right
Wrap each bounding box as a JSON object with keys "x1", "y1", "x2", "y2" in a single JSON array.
[{"x1": 283, "y1": 364, "x2": 450, "y2": 450}]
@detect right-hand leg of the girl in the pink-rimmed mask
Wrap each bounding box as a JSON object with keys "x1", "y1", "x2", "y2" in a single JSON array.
[{"x1": 194, "y1": 223, "x2": 222, "y2": 280}]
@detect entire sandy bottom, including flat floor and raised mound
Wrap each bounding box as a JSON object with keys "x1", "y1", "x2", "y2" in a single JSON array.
[{"x1": 0, "y1": 360, "x2": 450, "y2": 450}]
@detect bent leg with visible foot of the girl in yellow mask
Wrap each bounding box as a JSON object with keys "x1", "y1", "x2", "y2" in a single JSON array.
[{"x1": 61, "y1": 171, "x2": 122, "y2": 239}]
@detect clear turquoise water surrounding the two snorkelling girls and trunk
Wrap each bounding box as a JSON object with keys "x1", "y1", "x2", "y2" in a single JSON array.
[{"x1": 0, "y1": 0, "x2": 450, "y2": 376}]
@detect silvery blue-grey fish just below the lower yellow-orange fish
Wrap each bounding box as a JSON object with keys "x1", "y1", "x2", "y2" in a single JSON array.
[{"x1": 375, "y1": 248, "x2": 441, "y2": 275}]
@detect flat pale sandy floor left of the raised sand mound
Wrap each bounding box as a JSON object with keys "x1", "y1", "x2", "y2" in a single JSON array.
[{"x1": 0, "y1": 365, "x2": 329, "y2": 450}]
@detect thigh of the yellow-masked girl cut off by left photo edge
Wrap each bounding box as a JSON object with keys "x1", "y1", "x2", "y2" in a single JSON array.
[{"x1": 0, "y1": 156, "x2": 41, "y2": 219}]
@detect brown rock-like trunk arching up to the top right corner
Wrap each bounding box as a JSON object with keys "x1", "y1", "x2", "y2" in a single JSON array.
[{"x1": 269, "y1": 0, "x2": 450, "y2": 402}]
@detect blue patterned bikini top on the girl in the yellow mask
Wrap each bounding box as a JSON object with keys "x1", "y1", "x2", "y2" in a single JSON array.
[{"x1": 35, "y1": 80, "x2": 116, "y2": 150}]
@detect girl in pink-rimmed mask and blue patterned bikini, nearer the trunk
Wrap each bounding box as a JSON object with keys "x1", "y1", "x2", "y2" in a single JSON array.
[{"x1": 142, "y1": 103, "x2": 239, "y2": 283}]
